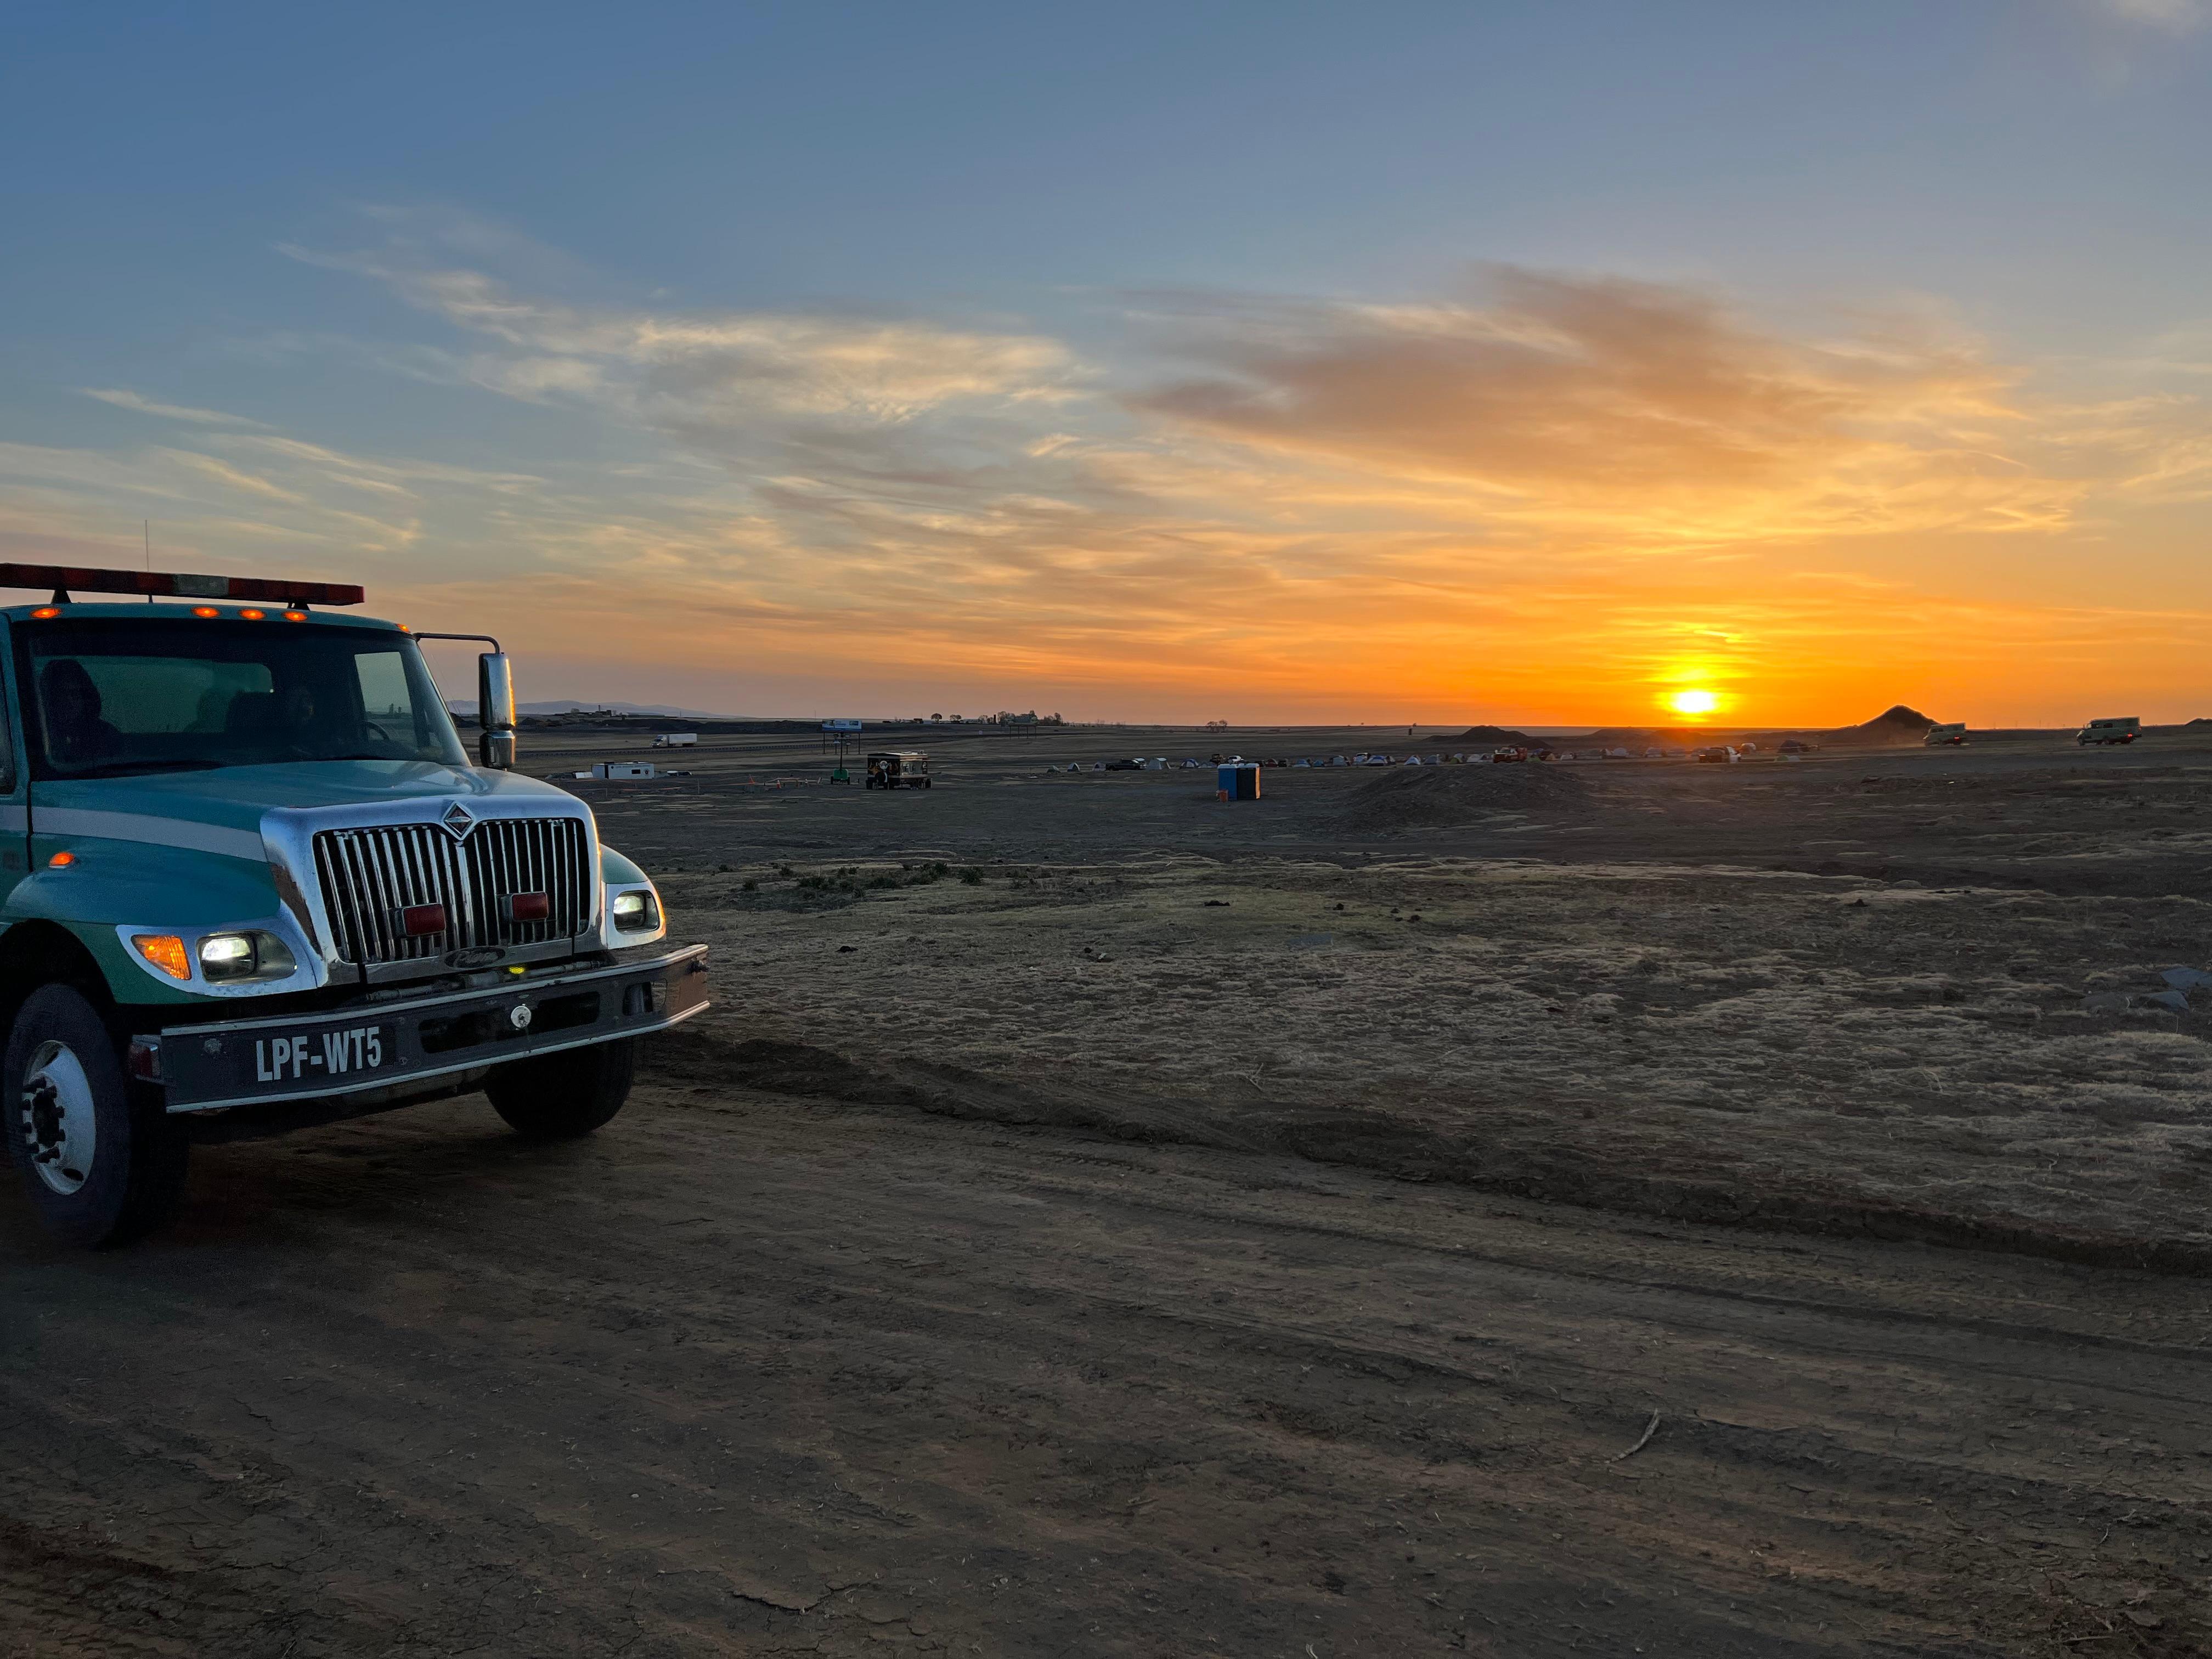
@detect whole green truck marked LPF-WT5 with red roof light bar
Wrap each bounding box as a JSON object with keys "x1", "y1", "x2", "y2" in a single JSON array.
[{"x1": 0, "y1": 566, "x2": 706, "y2": 1245}]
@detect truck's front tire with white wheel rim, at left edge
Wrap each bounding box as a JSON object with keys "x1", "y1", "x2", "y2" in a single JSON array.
[{"x1": 0, "y1": 984, "x2": 193, "y2": 1250}]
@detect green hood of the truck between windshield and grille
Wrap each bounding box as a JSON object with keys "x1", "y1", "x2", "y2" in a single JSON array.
[{"x1": 31, "y1": 761, "x2": 575, "y2": 834}]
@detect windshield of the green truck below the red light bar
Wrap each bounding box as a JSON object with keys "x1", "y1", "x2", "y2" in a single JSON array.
[{"x1": 18, "y1": 617, "x2": 467, "y2": 778}]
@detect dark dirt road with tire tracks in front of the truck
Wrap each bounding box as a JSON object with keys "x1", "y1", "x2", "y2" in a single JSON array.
[{"x1": 0, "y1": 1075, "x2": 2212, "y2": 1659}]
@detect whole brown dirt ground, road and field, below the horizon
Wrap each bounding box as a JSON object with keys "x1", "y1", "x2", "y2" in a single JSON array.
[{"x1": 0, "y1": 732, "x2": 2212, "y2": 1659}]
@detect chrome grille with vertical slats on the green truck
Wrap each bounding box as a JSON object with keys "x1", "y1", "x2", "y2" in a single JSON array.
[{"x1": 314, "y1": 819, "x2": 593, "y2": 967}]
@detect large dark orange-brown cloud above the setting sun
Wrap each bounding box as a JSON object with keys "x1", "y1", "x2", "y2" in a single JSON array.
[{"x1": 1135, "y1": 268, "x2": 2079, "y2": 546}]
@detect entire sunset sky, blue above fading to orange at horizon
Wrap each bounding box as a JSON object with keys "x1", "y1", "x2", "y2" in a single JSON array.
[{"x1": 0, "y1": 0, "x2": 2212, "y2": 725}]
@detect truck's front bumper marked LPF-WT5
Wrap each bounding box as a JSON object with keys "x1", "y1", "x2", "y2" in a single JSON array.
[{"x1": 131, "y1": 945, "x2": 706, "y2": 1113}]
